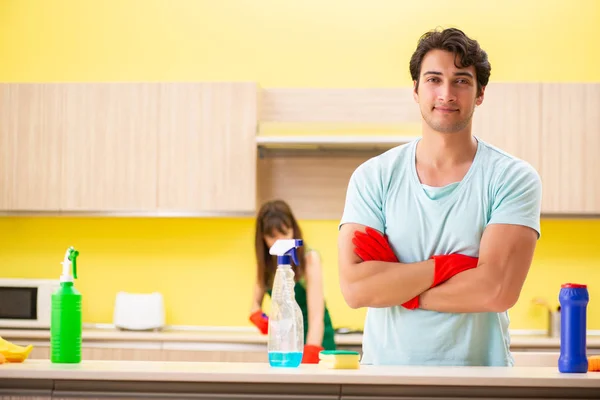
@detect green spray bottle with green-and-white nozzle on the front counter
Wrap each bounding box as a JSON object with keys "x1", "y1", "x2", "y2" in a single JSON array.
[{"x1": 50, "y1": 246, "x2": 82, "y2": 364}]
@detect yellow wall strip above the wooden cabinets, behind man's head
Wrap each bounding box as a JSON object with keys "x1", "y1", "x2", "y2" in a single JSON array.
[{"x1": 0, "y1": 0, "x2": 600, "y2": 87}]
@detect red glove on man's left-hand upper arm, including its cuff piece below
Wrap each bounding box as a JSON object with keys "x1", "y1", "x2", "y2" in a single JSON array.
[{"x1": 352, "y1": 227, "x2": 419, "y2": 310}]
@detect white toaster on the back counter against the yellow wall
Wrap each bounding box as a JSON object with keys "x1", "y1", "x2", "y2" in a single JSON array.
[{"x1": 113, "y1": 292, "x2": 165, "y2": 331}]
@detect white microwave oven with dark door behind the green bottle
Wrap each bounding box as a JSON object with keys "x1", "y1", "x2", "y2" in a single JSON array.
[{"x1": 0, "y1": 278, "x2": 60, "y2": 329}]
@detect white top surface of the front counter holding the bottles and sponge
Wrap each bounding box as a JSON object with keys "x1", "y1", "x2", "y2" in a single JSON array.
[{"x1": 0, "y1": 360, "x2": 600, "y2": 393}]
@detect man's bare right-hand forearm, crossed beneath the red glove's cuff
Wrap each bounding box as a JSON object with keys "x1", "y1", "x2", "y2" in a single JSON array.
[{"x1": 419, "y1": 266, "x2": 504, "y2": 313}]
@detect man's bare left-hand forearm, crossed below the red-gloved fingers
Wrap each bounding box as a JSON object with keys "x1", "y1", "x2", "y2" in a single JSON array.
[{"x1": 342, "y1": 260, "x2": 435, "y2": 308}]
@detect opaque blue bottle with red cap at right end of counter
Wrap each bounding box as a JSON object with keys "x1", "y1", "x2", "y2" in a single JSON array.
[{"x1": 558, "y1": 283, "x2": 590, "y2": 373}]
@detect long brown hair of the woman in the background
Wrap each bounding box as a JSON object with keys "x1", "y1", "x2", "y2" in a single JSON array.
[{"x1": 255, "y1": 200, "x2": 306, "y2": 288}]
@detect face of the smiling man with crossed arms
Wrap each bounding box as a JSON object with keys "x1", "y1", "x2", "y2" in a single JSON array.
[{"x1": 413, "y1": 50, "x2": 485, "y2": 133}]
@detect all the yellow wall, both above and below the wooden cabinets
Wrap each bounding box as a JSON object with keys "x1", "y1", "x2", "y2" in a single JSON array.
[{"x1": 0, "y1": 0, "x2": 600, "y2": 329}]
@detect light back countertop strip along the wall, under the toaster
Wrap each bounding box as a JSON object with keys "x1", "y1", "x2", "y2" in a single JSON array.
[{"x1": 0, "y1": 329, "x2": 600, "y2": 349}]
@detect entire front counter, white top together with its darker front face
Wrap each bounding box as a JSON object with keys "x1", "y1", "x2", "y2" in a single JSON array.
[{"x1": 0, "y1": 360, "x2": 600, "y2": 399}]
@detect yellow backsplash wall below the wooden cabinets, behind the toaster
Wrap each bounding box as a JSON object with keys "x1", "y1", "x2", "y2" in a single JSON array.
[{"x1": 0, "y1": 217, "x2": 600, "y2": 330}]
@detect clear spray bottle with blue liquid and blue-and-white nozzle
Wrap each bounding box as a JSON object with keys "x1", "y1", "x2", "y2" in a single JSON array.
[{"x1": 268, "y1": 239, "x2": 304, "y2": 368}]
